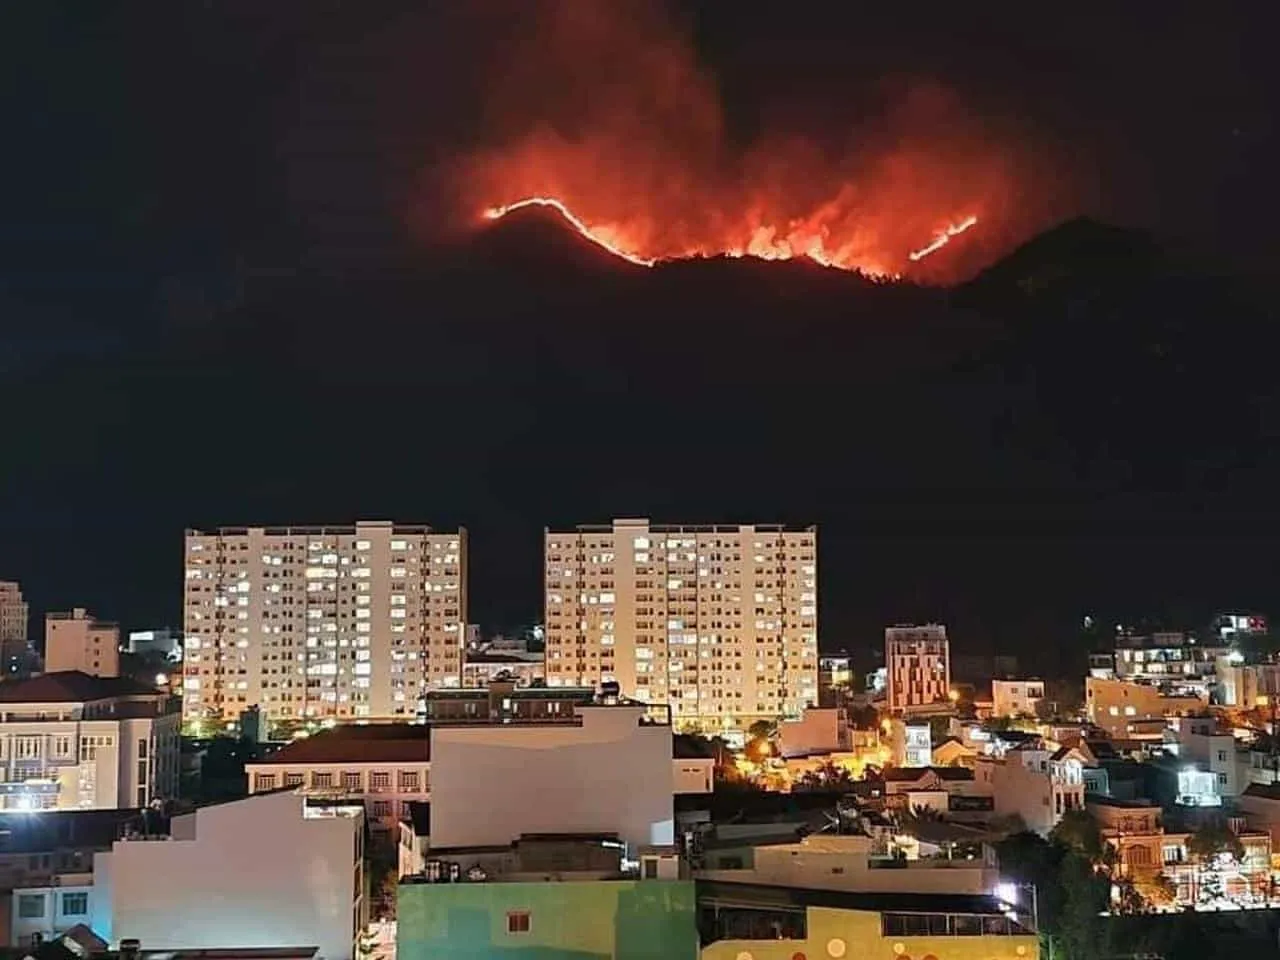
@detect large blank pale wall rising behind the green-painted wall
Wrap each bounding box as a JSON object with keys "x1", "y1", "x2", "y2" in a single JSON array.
[{"x1": 431, "y1": 707, "x2": 675, "y2": 849}]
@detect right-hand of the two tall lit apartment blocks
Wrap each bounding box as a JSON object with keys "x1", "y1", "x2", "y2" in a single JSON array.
[{"x1": 544, "y1": 520, "x2": 818, "y2": 730}]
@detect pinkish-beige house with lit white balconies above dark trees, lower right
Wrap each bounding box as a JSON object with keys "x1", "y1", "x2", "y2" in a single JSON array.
[{"x1": 977, "y1": 742, "x2": 1084, "y2": 836}]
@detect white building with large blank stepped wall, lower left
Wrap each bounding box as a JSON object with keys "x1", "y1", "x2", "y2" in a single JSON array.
[{"x1": 88, "y1": 791, "x2": 369, "y2": 960}]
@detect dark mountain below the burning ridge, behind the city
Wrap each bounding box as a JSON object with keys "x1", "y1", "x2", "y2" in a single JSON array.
[{"x1": 0, "y1": 211, "x2": 1280, "y2": 667}]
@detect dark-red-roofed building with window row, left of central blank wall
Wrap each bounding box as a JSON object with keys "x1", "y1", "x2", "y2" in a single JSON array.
[{"x1": 244, "y1": 723, "x2": 431, "y2": 846}]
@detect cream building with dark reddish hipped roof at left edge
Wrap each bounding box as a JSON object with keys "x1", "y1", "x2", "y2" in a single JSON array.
[{"x1": 0, "y1": 671, "x2": 180, "y2": 810}]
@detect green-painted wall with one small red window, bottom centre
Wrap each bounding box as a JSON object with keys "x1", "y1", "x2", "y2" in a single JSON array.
[{"x1": 396, "y1": 879, "x2": 698, "y2": 960}]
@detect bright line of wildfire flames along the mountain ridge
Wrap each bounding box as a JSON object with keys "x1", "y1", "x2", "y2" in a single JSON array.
[{"x1": 484, "y1": 196, "x2": 978, "y2": 279}]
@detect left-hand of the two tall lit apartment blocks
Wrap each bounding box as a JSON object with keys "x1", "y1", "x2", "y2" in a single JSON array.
[{"x1": 183, "y1": 521, "x2": 467, "y2": 721}]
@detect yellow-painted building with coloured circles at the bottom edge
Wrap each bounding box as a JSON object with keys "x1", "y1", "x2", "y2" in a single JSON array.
[{"x1": 698, "y1": 883, "x2": 1039, "y2": 960}]
